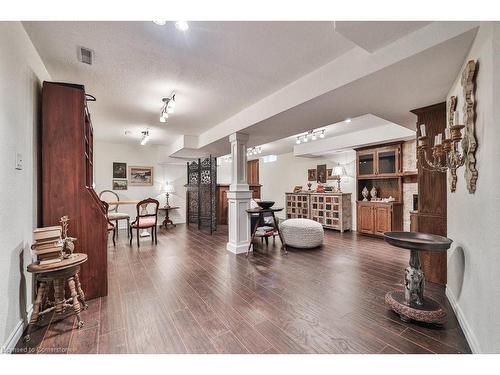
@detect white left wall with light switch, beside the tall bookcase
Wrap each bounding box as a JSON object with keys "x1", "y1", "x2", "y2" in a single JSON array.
[{"x1": 0, "y1": 22, "x2": 50, "y2": 352}]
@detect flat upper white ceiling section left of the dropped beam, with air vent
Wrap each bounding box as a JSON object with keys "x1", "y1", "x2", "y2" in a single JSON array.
[{"x1": 23, "y1": 22, "x2": 354, "y2": 144}]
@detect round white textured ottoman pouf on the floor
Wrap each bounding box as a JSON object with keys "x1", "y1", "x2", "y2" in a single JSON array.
[{"x1": 280, "y1": 219, "x2": 324, "y2": 249}]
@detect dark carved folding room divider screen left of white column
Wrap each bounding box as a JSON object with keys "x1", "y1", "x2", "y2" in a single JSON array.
[{"x1": 186, "y1": 156, "x2": 217, "y2": 234}]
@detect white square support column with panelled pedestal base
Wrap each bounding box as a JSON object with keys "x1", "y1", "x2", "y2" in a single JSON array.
[{"x1": 226, "y1": 133, "x2": 252, "y2": 254}]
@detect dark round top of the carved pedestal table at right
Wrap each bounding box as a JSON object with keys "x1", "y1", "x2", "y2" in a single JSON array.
[{"x1": 384, "y1": 232, "x2": 453, "y2": 251}]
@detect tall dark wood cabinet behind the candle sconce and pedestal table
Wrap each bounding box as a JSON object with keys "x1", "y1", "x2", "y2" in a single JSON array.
[{"x1": 411, "y1": 102, "x2": 447, "y2": 285}]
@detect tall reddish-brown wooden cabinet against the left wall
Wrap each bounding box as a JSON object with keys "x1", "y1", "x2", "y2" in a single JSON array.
[{"x1": 41, "y1": 82, "x2": 108, "y2": 299}]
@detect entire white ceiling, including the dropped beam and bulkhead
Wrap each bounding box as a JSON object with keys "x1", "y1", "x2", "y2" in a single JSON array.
[{"x1": 24, "y1": 21, "x2": 477, "y2": 160}]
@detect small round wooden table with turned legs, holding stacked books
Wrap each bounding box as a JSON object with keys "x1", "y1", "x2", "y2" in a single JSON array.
[{"x1": 24, "y1": 253, "x2": 88, "y2": 341}]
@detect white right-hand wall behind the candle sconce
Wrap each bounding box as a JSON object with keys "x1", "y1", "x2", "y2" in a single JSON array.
[{"x1": 446, "y1": 23, "x2": 500, "y2": 353}]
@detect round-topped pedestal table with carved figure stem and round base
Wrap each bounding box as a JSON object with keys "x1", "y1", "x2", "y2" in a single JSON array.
[{"x1": 384, "y1": 232, "x2": 453, "y2": 324}]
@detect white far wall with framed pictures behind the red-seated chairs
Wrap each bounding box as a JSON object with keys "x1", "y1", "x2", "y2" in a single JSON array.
[{"x1": 94, "y1": 141, "x2": 187, "y2": 228}]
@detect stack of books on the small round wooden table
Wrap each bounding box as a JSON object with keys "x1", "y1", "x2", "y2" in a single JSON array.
[{"x1": 31, "y1": 225, "x2": 63, "y2": 264}]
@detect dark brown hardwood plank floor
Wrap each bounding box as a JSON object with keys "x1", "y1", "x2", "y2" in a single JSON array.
[{"x1": 17, "y1": 225, "x2": 470, "y2": 354}]
